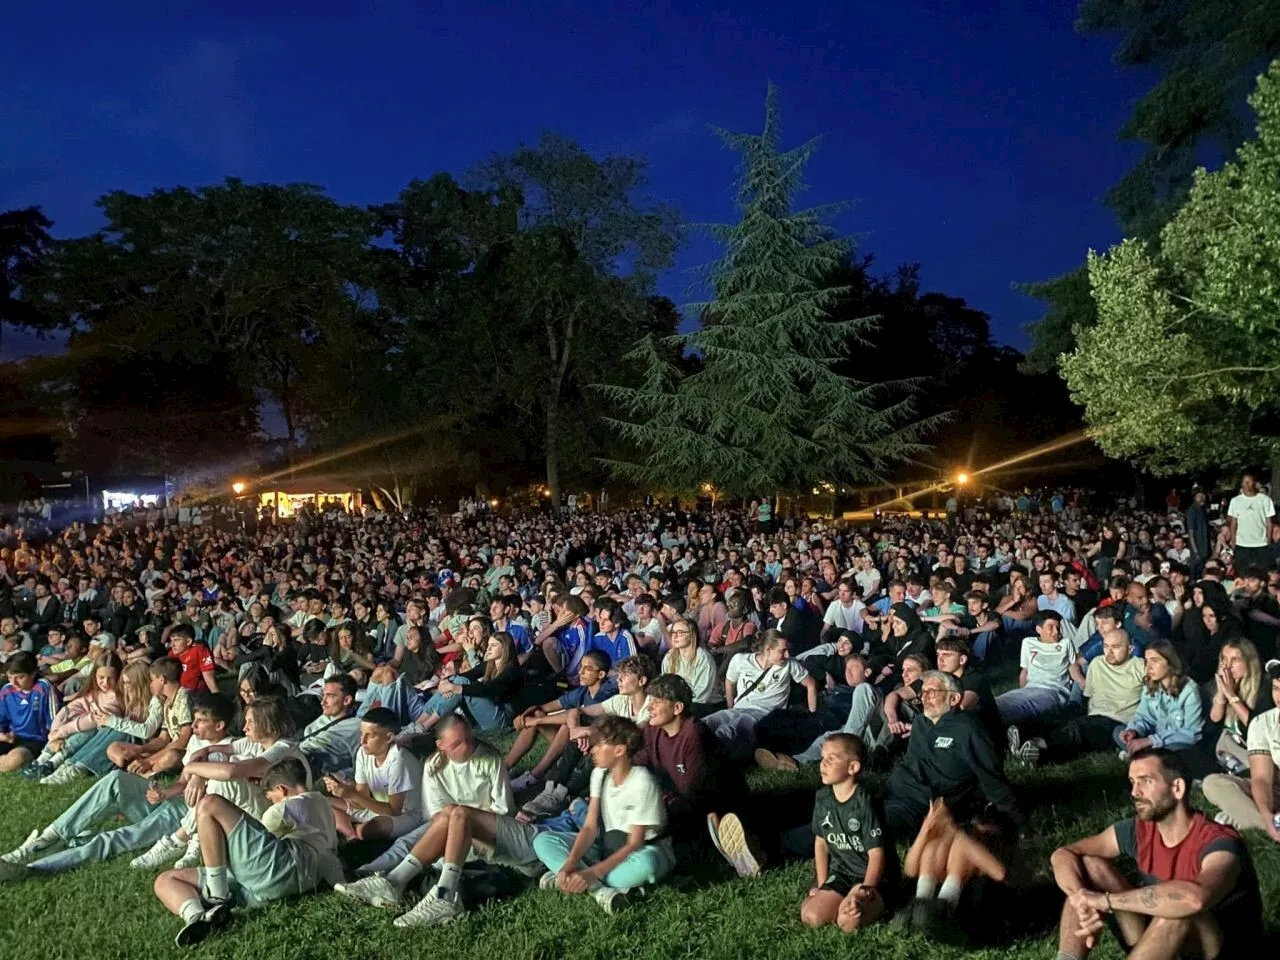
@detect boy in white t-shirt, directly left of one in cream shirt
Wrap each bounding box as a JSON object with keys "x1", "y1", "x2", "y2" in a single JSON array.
[{"x1": 324, "y1": 707, "x2": 422, "y2": 840}]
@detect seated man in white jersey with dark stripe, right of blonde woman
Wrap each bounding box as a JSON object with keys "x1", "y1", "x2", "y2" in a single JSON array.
[{"x1": 703, "y1": 628, "x2": 818, "y2": 759}]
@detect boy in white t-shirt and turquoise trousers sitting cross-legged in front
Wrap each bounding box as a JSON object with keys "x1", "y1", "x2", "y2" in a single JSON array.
[{"x1": 534, "y1": 717, "x2": 676, "y2": 913}]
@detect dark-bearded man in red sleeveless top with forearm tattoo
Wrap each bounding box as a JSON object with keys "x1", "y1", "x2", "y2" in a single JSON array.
[{"x1": 1051, "y1": 750, "x2": 1262, "y2": 960}]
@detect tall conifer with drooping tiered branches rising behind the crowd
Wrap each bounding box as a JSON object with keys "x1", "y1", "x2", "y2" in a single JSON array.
[{"x1": 599, "y1": 86, "x2": 931, "y2": 495}]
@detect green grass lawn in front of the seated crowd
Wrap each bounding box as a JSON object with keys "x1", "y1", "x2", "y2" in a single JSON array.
[{"x1": 0, "y1": 754, "x2": 1280, "y2": 960}]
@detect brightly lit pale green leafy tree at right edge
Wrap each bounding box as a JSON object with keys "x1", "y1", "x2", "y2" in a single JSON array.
[{"x1": 1062, "y1": 61, "x2": 1280, "y2": 474}]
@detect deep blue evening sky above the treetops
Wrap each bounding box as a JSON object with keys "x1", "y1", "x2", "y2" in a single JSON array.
[{"x1": 0, "y1": 0, "x2": 1147, "y2": 356}]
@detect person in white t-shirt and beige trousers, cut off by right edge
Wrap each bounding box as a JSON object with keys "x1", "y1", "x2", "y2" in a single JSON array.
[{"x1": 1204, "y1": 660, "x2": 1280, "y2": 842}]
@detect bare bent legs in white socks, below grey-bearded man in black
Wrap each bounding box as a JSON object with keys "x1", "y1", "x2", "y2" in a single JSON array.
[{"x1": 893, "y1": 800, "x2": 1014, "y2": 945}]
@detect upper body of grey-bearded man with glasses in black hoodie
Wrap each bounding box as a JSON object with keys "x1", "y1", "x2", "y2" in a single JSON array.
[{"x1": 884, "y1": 671, "x2": 1024, "y2": 840}]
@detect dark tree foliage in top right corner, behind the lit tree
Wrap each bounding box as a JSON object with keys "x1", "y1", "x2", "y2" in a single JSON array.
[{"x1": 1023, "y1": 0, "x2": 1280, "y2": 370}]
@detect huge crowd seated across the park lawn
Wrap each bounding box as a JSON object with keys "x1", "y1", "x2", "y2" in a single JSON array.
[{"x1": 0, "y1": 475, "x2": 1280, "y2": 960}]
